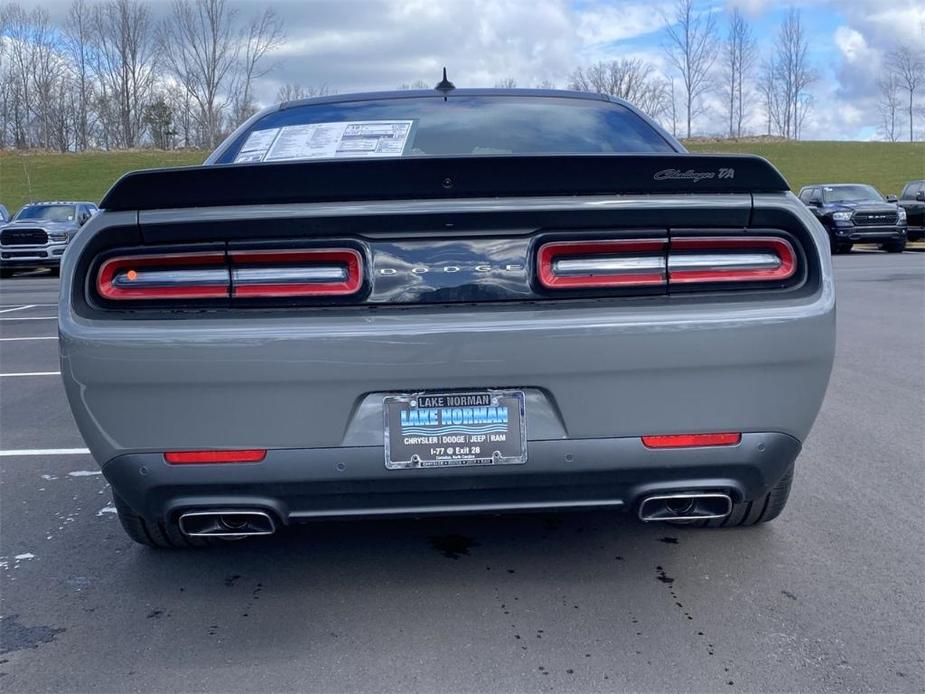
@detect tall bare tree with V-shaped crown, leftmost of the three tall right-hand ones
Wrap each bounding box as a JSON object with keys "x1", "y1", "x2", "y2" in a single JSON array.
[{"x1": 665, "y1": 0, "x2": 716, "y2": 137}]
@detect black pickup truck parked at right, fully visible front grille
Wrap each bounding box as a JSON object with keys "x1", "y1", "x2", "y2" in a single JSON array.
[{"x1": 800, "y1": 183, "x2": 906, "y2": 253}]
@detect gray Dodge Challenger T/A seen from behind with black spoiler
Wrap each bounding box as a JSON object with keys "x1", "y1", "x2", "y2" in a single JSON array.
[{"x1": 59, "y1": 88, "x2": 835, "y2": 547}]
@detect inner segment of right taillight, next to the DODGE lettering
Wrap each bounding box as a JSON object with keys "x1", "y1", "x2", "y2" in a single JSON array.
[{"x1": 537, "y1": 239, "x2": 667, "y2": 289}]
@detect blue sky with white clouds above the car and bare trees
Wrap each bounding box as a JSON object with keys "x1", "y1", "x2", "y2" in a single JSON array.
[{"x1": 41, "y1": 0, "x2": 925, "y2": 140}]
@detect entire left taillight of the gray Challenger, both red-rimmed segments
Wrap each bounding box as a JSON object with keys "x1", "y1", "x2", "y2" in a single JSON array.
[{"x1": 96, "y1": 248, "x2": 364, "y2": 301}]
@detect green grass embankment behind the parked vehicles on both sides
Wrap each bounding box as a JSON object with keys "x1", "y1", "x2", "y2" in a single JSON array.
[{"x1": 0, "y1": 139, "x2": 925, "y2": 212}]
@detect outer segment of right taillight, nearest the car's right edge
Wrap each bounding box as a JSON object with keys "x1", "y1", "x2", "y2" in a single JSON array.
[{"x1": 668, "y1": 236, "x2": 797, "y2": 285}]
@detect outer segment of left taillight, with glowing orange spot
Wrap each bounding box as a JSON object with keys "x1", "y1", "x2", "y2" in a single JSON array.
[{"x1": 96, "y1": 251, "x2": 231, "y2": 300}]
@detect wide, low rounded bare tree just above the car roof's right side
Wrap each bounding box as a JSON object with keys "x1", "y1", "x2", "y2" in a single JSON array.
[{"x1": 569, "y1": 58, "x2": 670, "y2": 118}]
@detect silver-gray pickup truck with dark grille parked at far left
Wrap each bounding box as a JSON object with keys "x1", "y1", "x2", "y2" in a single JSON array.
[{"x1": 0, "y1": 202, "x2": 97, "y2": 277}]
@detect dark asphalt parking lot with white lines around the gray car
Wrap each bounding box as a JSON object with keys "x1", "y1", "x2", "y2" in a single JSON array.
[{"x1": 0, "y1": 251, "x2": 925, "y2": 692}]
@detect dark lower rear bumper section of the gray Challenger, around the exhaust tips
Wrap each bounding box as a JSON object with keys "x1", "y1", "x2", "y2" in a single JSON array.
[{"x1": 103, "y1": 433, "x2": 800, "y2": 524}]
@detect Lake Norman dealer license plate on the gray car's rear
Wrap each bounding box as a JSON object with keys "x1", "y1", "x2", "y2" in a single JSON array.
[{"x1": 383, "y1": 390, "x2": 527, "y2": 470}]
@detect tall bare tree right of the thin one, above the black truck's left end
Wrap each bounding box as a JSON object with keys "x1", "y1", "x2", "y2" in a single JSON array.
[{"x1": 772, "y1": 8, "x2": 816, "y2": 139}]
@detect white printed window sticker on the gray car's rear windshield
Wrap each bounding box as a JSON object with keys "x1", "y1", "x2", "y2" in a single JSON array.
[{"x1": 235, "y1": 120, "x2": 414, "y2": 162}]
